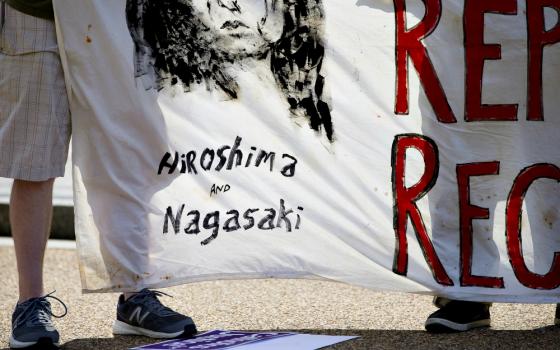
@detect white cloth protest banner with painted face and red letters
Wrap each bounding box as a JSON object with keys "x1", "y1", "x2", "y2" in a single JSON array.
[{"x1": 55, "y1": 0, "x2": 560, "y2": 302}]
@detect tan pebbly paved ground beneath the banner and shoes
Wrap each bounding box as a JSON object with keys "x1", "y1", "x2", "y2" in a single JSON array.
[{"x1": 0, "y1": 247, "x2": 560, "y2": 350}]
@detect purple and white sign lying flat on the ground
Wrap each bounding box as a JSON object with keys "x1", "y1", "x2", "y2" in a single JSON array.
[{"x1": 133, "y1": 330, "x2": 296, "y2": 350}]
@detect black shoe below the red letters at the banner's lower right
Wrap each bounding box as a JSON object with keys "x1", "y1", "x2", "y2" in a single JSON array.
[{"x1": 424, "y1": 300, "x2": 490, "y2": 333}]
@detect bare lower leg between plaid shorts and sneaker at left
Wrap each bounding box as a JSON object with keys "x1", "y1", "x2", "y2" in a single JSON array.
[{"x1": 10, "y1": 179, "x2": 54, "y2": 302}]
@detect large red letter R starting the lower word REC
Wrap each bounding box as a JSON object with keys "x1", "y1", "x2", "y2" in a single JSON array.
[{"x1": 391, "y1": 134, "x2": 453, "y2": 286}]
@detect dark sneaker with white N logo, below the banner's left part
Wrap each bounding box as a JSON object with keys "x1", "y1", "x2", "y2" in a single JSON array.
[{"x1": 113, "y1": 289, "x2": 196, "y2": 338}]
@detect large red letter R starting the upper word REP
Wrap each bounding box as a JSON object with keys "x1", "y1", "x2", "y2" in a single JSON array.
[{"x1": 394, "y1": 0, "x2": 457, "y2": 123}]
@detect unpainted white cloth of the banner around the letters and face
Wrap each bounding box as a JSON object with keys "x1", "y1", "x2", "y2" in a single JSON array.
[{"x1": 55, "y1": 0, "x2": 560, "y2": 302}]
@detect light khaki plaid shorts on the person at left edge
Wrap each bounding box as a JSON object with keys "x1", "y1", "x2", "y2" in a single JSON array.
[{"x1": 0, "y1": 0, "x2": 71, "y2": 181}]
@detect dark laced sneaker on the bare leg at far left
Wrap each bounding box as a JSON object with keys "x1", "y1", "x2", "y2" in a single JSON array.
[{"x1": 10, "y1": 293, "x2": 67, "y2": 349}]
